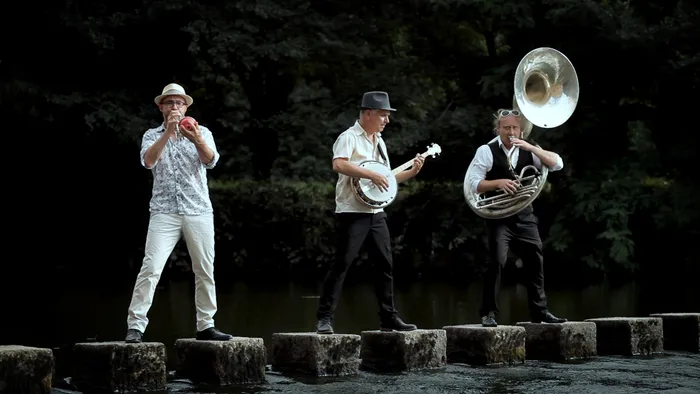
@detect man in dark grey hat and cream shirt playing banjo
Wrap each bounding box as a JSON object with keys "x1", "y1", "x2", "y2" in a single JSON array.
[{"x1": 316, "y1": 92, "x2": 424, "y2": 334}]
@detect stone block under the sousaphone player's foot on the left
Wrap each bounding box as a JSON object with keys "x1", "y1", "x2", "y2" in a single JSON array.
[{"x1": 443, "y1": 324, "x2": 525, "y2": 365}]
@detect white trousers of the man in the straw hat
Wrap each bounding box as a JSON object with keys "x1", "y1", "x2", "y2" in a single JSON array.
[{"x1": 127, "y1": 213, "x2": 217, "y2": 332}]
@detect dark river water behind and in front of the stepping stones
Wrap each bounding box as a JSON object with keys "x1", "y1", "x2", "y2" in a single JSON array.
[{"x1": 5, "y1": 279, "x2": 700, "y2": 394}]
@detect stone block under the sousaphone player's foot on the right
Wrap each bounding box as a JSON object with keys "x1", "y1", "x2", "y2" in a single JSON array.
[{"x1": 516, "y1": 322, "x2": 597, "y2": 361}]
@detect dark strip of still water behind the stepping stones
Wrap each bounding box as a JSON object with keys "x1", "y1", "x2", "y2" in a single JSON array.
[{"x1": 35, "y1": 280, "x2": 700, "y2": 368}]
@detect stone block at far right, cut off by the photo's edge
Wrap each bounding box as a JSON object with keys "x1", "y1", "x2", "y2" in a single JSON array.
[{"x1": 650, "y1": 313, "x2": 700, "y2": 353}]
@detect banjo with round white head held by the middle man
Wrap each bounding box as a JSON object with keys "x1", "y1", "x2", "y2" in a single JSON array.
[{"x1": 350, "y1": 143, "x2": 442, "y2": 208}]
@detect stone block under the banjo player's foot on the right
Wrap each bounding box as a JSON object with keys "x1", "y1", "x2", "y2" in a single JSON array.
[{"x1": 360, "y1": 330, "x2": 447, "y2": 372}]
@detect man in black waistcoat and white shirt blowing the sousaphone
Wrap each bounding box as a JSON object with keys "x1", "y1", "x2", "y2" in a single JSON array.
[{"x1": 465, "y1": 109, "x2": 566, "y2": 327}]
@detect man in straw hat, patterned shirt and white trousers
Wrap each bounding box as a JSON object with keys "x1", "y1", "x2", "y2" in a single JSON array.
[{"x1": 125, "y1": 83, "x2": 232, "y2": 343}]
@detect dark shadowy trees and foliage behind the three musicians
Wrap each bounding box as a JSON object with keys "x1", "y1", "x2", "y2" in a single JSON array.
[{"x1": 6, "y1": 0, "x2": 700, "y2": 288}]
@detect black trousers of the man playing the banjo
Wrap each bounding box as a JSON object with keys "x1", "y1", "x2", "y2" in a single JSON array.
[{"x1": 316, "y1": 212, "x2": 396, "y2": 319}]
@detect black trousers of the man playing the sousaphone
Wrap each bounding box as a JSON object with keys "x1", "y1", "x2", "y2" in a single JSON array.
[{"x1": 479, "y1": 209, "x2": 547, "y2": 317}]
